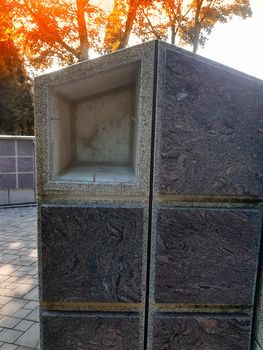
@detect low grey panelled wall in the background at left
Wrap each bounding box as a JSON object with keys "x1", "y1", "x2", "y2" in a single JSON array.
[{"x1": 0, "y1": 135, "x2": 35, "y2": 205}]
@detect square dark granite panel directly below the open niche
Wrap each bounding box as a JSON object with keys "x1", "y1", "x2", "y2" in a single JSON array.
[{"x1": 41, "y1": 206, "x2": 143, "y2": 302}]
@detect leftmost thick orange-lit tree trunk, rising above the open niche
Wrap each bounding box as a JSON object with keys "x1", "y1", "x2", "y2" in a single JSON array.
[{"x1": 76, "y1": 0, "x2": 89, "y2": 61}]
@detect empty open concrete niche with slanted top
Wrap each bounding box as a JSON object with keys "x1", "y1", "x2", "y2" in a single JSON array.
[{"x1": 49, "y1": 64, "x2": 140, "y2": 183}]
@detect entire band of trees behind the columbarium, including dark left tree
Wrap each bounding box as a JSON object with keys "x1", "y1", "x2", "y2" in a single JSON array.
[{"x1": 0, "y1": 0, "x2": 252, "y2": 134}]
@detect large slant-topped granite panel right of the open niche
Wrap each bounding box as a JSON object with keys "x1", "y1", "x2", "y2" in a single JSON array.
[{"x1": 155, "y1": 49, "x2": 263, "y2": 196}]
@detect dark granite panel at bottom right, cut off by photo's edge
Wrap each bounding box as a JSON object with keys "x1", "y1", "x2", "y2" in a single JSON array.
[{"x1": 153, "y1": 314, "x2": 251, "y2": 350}]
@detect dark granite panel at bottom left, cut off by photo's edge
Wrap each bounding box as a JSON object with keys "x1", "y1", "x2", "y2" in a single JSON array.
[{"x1": 42, "y1": 313, "x2": 139, "y2": 350}]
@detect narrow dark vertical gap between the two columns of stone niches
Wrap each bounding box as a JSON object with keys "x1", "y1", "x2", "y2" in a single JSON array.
[{"x1": 144, "y1": 40, "x2": 159, "y2": 350}]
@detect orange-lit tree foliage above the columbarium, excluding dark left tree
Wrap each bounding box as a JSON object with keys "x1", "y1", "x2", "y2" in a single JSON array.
[{"x1": 3, "y1": 0, "x2": 252, "y2": 68}]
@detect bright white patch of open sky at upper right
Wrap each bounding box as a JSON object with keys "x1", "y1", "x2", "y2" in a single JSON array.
[{"x1": 198, "y1": 0, "x2": 263, "y2": 79}]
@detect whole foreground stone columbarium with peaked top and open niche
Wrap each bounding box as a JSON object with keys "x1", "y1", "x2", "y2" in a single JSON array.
[{"x1": 35, "y1": 41, "x2": 263, "y2": 350}]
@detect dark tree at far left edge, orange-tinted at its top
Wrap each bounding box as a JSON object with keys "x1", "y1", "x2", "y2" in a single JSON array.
[{"x1": 0, "y1": 0, "x2": 34, "y2": 135}]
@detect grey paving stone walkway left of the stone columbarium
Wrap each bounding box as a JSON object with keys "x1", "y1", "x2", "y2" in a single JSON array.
[{"x1": 0, "y1": 207, "x2": 39, "y2": 350}]
